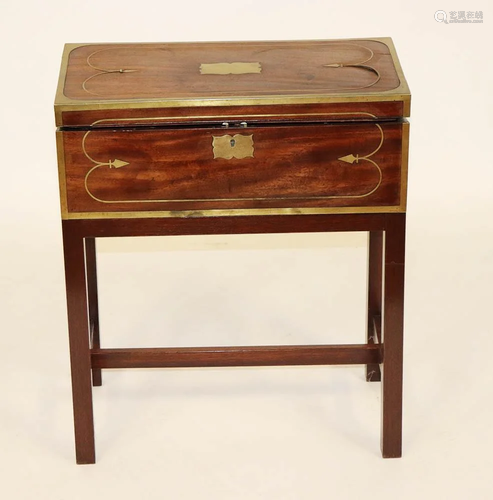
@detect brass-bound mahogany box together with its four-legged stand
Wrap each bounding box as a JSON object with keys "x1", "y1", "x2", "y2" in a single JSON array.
[{"x1": 55, "y1": 38, "x2": 410, "y2": 463}]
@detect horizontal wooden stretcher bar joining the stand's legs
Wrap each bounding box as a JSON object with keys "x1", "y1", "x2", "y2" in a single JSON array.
[{"x1": 91, "y1": 344, "x2": 382, "y2": 368}]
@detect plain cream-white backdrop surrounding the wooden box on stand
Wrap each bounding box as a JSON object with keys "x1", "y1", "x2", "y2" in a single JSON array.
[{"x1": 0, "y1": 0, "x2": 493, "y2": 500}]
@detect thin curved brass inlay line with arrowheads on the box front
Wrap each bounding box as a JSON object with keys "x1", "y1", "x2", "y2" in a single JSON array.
[{"x1": 82, "y1": 112, "x2": 384, "y2": 204}]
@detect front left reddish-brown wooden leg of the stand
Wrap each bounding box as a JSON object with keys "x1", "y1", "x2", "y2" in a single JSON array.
[{"x1": 63, "y1": 223, "x2": 95, "y2": 464}]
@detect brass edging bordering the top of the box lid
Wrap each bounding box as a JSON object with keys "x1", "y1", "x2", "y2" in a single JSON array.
[{"x1": 55, "y1": 38, "x2": 411, "y2": 126}]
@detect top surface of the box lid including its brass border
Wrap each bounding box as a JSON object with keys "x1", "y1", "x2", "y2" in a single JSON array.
[{"x1": 55, "y1": 38, "x2": 410, "y2": 121}]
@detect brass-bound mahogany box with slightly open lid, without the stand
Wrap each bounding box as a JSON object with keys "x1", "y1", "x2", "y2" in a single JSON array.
[{"x1": 55, "y1": 38, "x2": 410, "y2": 219}]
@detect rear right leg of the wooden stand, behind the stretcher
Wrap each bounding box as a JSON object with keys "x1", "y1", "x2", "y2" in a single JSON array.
[{"x1": 366, "y1": 231, "x2": 383, "y2": 382}]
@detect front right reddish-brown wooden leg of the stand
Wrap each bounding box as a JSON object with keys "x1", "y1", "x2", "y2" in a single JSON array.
[{"x1": 382, "y1": 214, "x2": 406, "y2": 458}]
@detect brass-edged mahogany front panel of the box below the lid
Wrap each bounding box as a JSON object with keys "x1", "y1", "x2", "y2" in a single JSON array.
[{"x1": 58, "y1": 122, "x2": 408, "y2": 218}]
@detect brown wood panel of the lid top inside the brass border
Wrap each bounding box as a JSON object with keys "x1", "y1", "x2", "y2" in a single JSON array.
[{"x1": 64, "y1": 40, "x2": 400, "y2": 101}]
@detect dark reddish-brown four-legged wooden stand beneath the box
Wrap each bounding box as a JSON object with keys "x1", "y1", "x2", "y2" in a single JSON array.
[{"x1": 63, "y1": 213, "x2": 406, "y2": 464}]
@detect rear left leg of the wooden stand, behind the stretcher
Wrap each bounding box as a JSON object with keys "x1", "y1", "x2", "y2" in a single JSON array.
[{"x1": 84, "y1": 238, "x2": 103, "y2": 386}]
